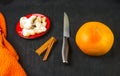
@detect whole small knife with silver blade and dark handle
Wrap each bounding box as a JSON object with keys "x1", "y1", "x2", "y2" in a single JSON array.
[{"x1": 62, "y1": 12, "x2": 70, "y2": 63}]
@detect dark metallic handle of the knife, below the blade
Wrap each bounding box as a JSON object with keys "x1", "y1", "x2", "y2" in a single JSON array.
[{"x1": 62, "y1": 37, "x2": 69, "y2": 63}]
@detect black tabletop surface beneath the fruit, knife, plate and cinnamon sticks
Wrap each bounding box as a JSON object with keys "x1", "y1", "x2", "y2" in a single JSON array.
[{"x1": 0, "y1": 0, "x2": 120, "y2": 76}]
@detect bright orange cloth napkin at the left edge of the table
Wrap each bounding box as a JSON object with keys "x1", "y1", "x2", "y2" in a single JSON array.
[{"x1": 0, "y1": 12, "x2": 27, "y2": 76}]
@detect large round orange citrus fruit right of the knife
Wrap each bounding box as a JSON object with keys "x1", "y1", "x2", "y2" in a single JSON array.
[{"x1": 75, "y1": 22, "x2": 114, "y2": 56}]
